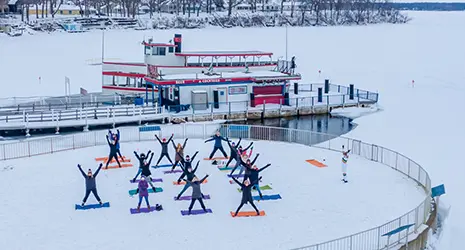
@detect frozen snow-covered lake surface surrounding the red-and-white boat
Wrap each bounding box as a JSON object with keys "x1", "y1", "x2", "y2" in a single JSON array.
[{"x1": 0, "y1": 12, "x2": 465, "y2": 250}]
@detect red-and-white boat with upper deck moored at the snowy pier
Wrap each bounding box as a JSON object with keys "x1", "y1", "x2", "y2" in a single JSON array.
[{"x1": 102, "y1": 34, "x2": 301, "y2": 111}]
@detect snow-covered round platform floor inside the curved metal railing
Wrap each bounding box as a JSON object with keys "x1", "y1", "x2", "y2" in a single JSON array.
[{"x1": 0, "y1": 139, "x2": 425, "y2": 249}]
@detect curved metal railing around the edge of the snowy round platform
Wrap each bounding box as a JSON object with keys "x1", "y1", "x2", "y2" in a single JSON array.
[{"x1": 0, "y1": 123, "x2": 431, "y2": 250}]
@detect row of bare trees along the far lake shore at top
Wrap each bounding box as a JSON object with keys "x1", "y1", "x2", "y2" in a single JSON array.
[{"x1": 10, "y1": 0, "x2": 399, "y2": 25}]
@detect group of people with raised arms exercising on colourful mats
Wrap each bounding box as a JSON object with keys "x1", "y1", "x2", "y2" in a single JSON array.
[{"x1": 78, "y1": 130, "x2": 271, "y2": 216}]
